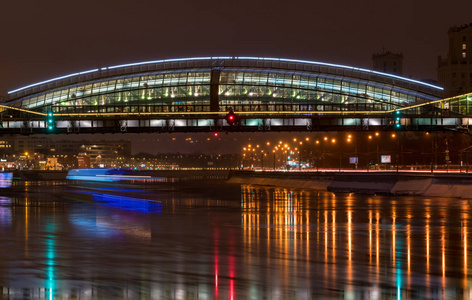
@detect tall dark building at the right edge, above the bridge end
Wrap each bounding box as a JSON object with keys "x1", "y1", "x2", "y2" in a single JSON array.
[{"x1": 438, "y1": 23, "x2": 472, "y2": 97}]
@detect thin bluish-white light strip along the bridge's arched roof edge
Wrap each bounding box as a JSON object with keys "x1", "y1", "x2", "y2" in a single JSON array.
[{"x1": 8, "y1": 56, "x2": 444, "y2": 94}]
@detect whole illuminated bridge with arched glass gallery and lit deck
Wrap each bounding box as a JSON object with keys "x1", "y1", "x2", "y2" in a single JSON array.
[{"x1": 0, "y1": 57, "x2": 472, "y2": 134}]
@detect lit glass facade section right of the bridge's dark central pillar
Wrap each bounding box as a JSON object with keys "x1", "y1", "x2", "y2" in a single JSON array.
[{"x1": 219, "y1": 69, "x2": 438, "y2": 111}]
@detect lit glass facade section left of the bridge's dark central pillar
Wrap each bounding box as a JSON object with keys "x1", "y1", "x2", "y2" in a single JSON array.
[{"x1": 18, "y1": 70, "x2": 211, "y2": 113}]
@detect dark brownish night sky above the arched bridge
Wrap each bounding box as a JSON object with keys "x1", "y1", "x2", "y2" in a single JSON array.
[{"x1": 0, "y1": 0, "x2": 472, "y2": 154}]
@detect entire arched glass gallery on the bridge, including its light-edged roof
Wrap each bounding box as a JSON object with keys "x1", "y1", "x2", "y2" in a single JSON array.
[{"x1": 2, "y1": 57, "x2": 442, "y2": 113}]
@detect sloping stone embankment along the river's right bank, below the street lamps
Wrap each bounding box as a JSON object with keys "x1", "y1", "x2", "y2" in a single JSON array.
[{"x1": 229, "y1": 171, "x2": 472, "y2": 198}]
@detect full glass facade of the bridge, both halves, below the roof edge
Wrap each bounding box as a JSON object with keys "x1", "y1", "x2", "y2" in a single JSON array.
[{"x1": 7, "y1": 57, "x2": 446, "y2": 114}]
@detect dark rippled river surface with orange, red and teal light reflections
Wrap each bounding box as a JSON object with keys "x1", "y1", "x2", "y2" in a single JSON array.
[{"x1": 0, "y1": 182, "x2": 472, "y2": 299}]
